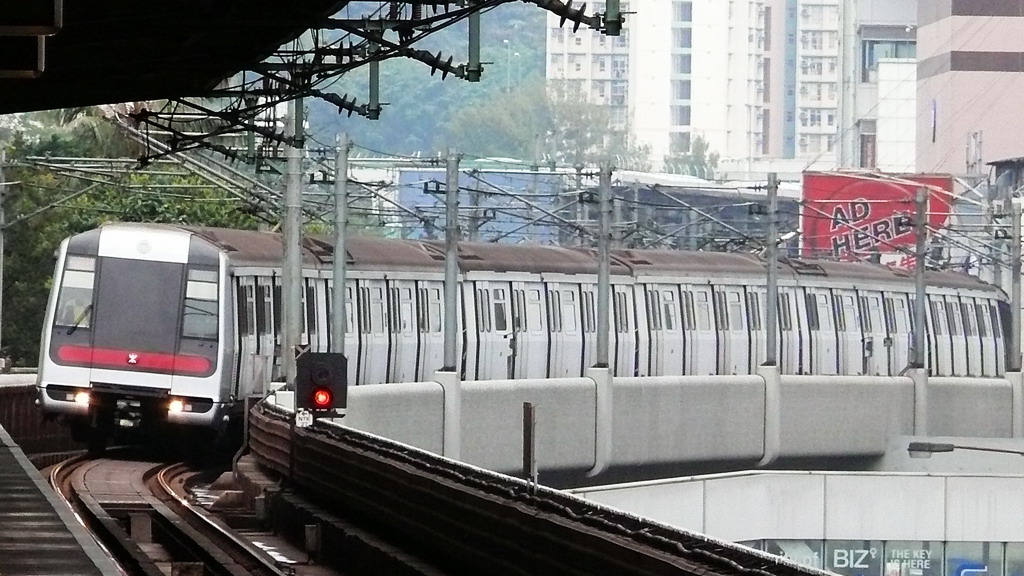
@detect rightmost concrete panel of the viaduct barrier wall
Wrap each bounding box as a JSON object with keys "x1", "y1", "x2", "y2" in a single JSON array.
[{"x1": 928, "y1": 378, "x2": 1013, "y2": 438}]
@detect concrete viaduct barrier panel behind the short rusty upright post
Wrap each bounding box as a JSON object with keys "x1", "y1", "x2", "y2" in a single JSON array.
[{"x1": 460, "y1": 378, "x2": 597, "y2": 476}]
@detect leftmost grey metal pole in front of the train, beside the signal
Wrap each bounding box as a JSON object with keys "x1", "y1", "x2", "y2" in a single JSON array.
[{"x1": 281, "y1": 98, "x2": 303, "y2": 383}]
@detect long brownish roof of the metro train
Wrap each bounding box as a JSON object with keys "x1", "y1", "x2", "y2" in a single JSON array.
[{"x1": 96, "y1": 224, "x2": 1000, "y2": 292}]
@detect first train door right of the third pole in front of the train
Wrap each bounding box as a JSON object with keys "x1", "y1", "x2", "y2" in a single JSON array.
[{"x1": 475, "y1": 281, "x2": 514, "y2": 380}]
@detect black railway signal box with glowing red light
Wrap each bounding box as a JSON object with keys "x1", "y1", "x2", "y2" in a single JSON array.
[{"x1": 295, "y1": 352, "x2": 348, "y2": 413}]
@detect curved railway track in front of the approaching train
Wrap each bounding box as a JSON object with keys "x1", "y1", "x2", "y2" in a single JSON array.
[{"x1": 49, "y1": 450, "x2": 319, "y2": 576}]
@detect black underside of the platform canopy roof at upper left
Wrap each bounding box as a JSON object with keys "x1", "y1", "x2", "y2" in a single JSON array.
[{"x1": 0, "y1": 0, "x2": 348, "y2": 114}]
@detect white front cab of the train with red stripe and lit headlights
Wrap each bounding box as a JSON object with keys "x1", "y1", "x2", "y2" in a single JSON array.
[{"x1": 37, "y1": 225, "x2": 231, "y2": 446}]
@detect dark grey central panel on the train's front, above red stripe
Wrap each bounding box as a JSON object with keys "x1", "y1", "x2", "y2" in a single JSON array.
[{"x1": 92, "y1": 257, "x2": 185, "y2": 354}]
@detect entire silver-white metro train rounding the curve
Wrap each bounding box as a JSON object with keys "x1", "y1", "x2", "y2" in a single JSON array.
[{"x1": 38, "y1": 223, "x2": 1008, "y2": 446}]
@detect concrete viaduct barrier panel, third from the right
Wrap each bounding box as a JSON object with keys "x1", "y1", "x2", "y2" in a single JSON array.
[{"x1": 609, "y1": 376, "x2": 765, "y2": 466}]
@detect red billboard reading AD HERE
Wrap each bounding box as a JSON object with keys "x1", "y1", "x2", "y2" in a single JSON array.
[{"x1": 801, "y1": 172, "x2": 953, "y2": 265}]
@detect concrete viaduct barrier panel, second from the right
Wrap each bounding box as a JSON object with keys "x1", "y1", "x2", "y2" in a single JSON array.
[{"x1": 779, "y1": 376, "x2": 913, "y2": 457}]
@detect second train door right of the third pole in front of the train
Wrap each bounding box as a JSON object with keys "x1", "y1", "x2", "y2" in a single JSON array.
[{"x1": 509, "y1": 282, "x2": 548, "y2": 378}]
